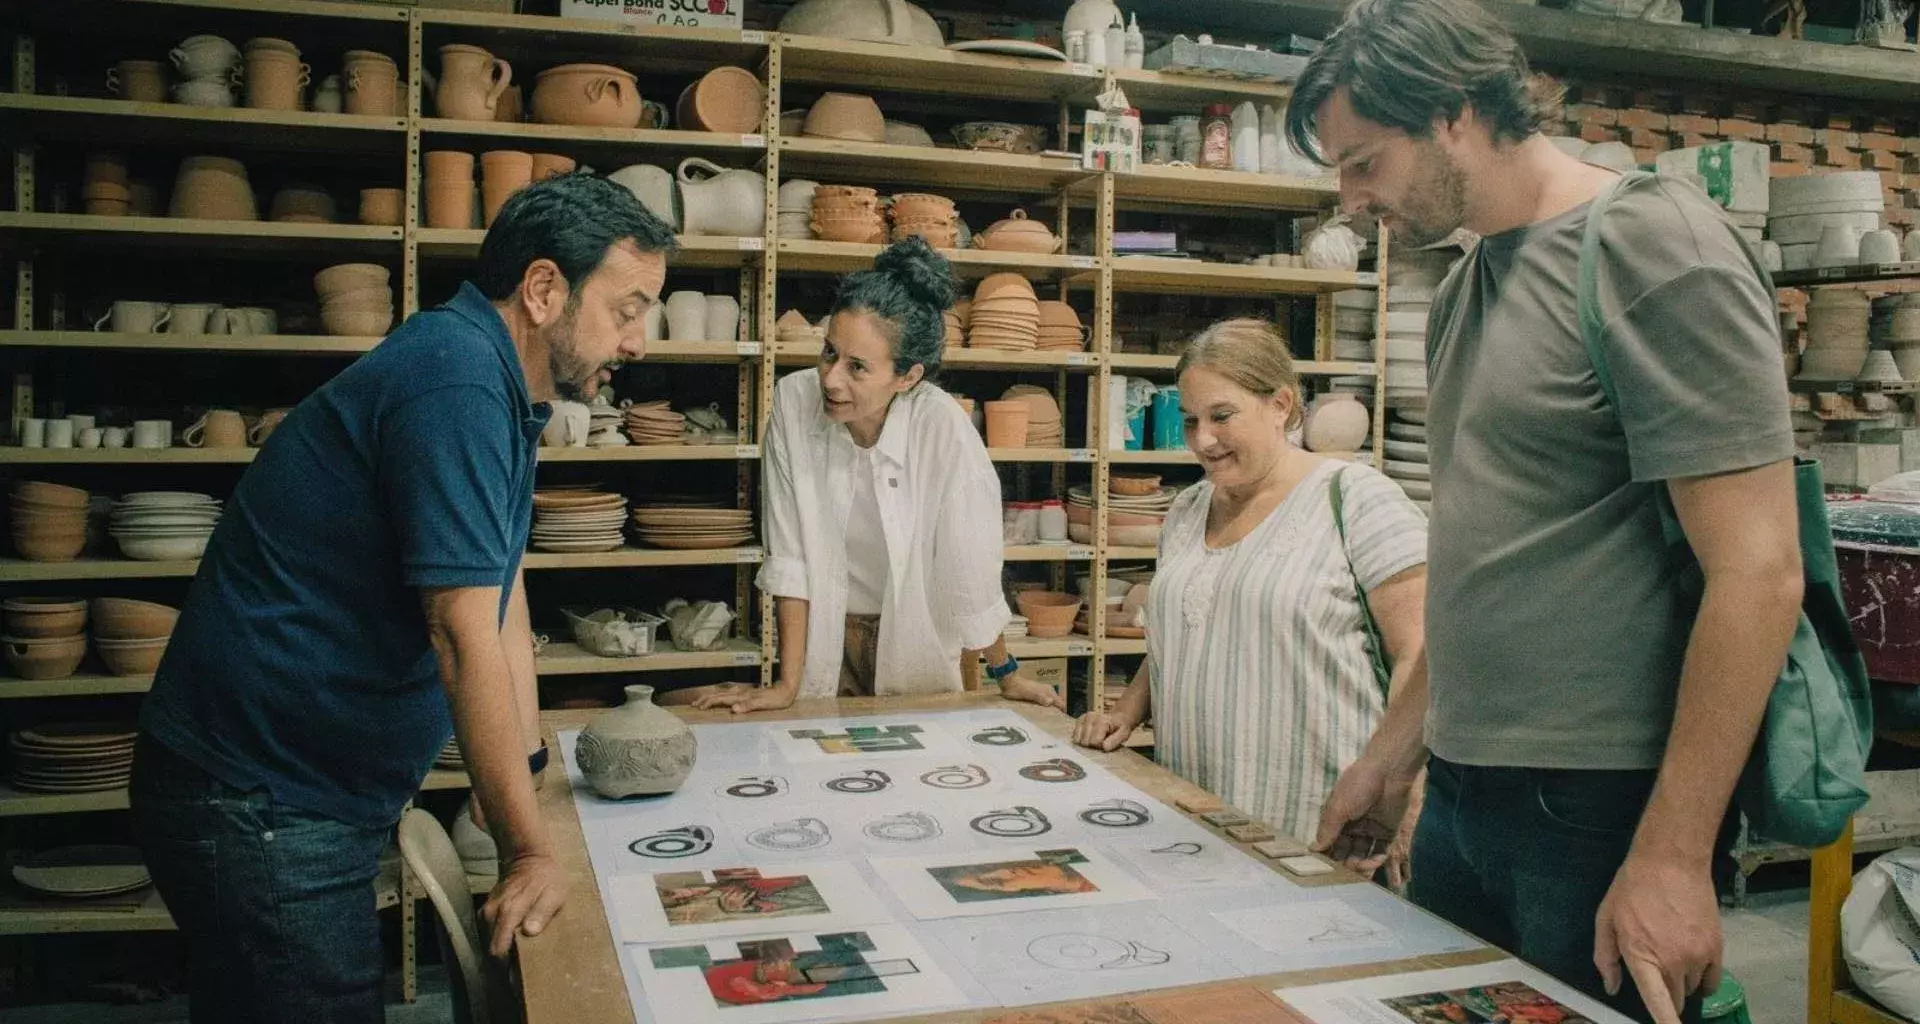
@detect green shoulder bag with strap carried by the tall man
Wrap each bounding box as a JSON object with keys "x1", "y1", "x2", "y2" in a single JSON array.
[{"x1": 1578, "y1": 171, "x2": 1874, "y2": 847}]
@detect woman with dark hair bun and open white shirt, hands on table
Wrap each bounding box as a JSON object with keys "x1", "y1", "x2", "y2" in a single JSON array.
[{"x1": 699, "y1": 238, "x2": 1064, "y2": 713}]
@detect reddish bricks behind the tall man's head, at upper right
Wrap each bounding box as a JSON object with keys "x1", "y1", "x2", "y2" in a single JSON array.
[{"x1": 1561, "y1": 83, "x2": 1920, "y2": 231}]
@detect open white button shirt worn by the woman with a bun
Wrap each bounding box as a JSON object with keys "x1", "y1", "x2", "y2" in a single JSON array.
[{"x1": 755, "y1": 369, "x2": 1012, "y2": 697}]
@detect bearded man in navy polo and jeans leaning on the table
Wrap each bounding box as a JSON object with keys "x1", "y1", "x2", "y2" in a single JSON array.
[{"x1": 132, "y1": 175, "x2": 674, "y2": 1022}]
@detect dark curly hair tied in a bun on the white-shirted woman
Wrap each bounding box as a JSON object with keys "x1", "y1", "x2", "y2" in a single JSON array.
[{"x1": 829, "y1": 234, "x2": 956, "y2": 378}]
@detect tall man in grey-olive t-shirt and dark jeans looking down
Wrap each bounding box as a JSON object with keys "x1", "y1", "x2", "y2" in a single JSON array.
[{"x1": 1288, "y1": 0, "x2": 1801, "y2": 1022}]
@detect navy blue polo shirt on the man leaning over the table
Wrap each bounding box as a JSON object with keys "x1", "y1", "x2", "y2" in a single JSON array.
[{"x1": 140, "y1": 284, "x2": 549, "y2": 828}]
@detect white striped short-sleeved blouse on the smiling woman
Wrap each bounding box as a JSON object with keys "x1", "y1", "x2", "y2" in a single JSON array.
[{"x1": 1146, "y1": 461, "x2": 1427, "y2": 841}]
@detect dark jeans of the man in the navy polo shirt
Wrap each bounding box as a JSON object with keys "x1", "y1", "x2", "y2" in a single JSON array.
[{"x1": 132, "y1": 736, "x2": 388, "y2": 1024}]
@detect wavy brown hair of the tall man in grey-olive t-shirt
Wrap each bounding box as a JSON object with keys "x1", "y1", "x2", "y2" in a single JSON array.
[{"x1": 1286, "y1": 0, "x2": 1563, "y2": 167}]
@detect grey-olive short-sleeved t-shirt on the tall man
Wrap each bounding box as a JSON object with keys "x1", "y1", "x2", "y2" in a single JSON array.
[{"x1": 1427, "y1": 179, "x2": 1793, "y2": 768}]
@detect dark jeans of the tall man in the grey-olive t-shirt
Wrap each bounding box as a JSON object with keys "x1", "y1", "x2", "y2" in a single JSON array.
[{"x1": 1407, "y1": 757, "x2": 1724, "y2": 1024}]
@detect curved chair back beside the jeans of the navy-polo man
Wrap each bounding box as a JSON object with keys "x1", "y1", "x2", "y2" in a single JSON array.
[{"x1": 399, "y1": 807, "x2": 520, "y2": 1024}]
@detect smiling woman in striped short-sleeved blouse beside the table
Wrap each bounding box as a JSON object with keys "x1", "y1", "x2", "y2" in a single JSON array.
[{"x1": 1073, "y1": 319, "x2": 1427, "y2": 882}]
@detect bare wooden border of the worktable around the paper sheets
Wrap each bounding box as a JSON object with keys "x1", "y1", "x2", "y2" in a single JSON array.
[{"x1": 518, "y1": 694, "x2": 1505, "y2": 1024}]
